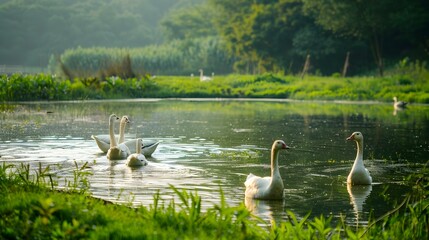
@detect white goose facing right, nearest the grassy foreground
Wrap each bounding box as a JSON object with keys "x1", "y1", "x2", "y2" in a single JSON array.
[{"x1": 244, "y1": 140, "x2": 289, "y2": 199}]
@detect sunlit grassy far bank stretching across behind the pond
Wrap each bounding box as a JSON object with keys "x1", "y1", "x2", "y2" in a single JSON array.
[{"x1": 0, "y1": 70, "x2": 429, "y2": 103}]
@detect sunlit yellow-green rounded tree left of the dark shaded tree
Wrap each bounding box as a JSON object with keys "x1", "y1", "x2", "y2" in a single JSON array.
[{"x1": 212, "y1": 0, "x2": 347, "y2": 73}]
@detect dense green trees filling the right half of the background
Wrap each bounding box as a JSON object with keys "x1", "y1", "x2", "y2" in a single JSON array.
[{"x1": 210, "y1": 0, "x2": 429, "y2": 73}]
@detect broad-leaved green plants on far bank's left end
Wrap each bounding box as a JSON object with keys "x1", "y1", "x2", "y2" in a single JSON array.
[{"x1": 0, "y1": 74, "x2": 158, "y2": 101}]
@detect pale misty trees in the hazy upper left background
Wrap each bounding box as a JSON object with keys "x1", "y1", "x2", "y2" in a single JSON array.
[{"x1": 0, "y1": 0, "x2": 181, "y2": 67}]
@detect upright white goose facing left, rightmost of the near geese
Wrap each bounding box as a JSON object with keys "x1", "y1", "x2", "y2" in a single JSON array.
[{"x1": 346, "y1": 132, "x2": 372, "y2": 185}]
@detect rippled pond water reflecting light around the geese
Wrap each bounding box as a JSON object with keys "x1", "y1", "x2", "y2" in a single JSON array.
[{"x1": 0, "y1": 99, "x2": 429, "y2": 225}]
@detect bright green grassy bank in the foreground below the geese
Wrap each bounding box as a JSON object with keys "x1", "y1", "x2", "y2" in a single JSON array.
[{"x1": 0, "y1": 163, "x2": 429, "y2": 239}]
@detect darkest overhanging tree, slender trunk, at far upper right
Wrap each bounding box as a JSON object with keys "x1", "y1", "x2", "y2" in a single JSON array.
[{"x1": 302, "y1": 0, "x2": 429, "y2": 76}]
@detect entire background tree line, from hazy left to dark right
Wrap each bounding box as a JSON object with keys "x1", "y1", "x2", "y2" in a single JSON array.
[{"x1": 0, "y1": 0, "x2": 429, "y2": 75}]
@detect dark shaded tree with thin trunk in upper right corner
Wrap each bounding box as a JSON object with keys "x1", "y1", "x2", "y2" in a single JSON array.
[{"x1": 303, "y1": 0, "x2": 429, "y2": 75}]
